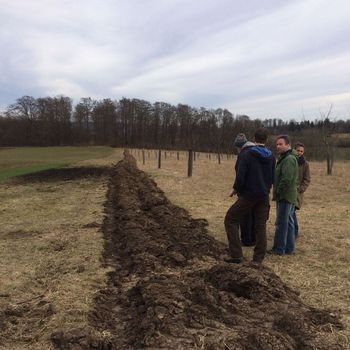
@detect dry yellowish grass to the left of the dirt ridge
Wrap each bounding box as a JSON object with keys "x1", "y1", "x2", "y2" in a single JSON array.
[{"x1": 0, "y1": 150, "x2": 121, "y2": 350}]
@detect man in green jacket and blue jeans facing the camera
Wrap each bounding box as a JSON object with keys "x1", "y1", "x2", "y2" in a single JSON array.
[{"x1": 271, "y1": 135, "x2": 298, "y2": 255}]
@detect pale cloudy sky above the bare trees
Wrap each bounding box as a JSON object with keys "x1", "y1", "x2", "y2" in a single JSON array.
[{"x1": 0, "y1": 0, "x2": 350, "y2": 121}]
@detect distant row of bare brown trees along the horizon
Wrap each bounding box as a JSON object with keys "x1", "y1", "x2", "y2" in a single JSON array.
[{"x1": 0, "y1": 96, "x2": 350, "y2": 158}]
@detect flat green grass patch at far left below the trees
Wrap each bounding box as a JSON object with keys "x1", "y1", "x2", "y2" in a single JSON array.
[{"x1": 0, "y1": 146, "x2": 113, "y2": 181}]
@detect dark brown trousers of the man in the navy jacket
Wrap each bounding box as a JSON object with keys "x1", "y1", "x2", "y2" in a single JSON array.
[{"x1": 225, "y1": 197, "x2": 270, "y2": 262}]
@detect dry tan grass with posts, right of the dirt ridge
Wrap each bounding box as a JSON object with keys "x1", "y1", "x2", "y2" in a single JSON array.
[{"x1": 134, "y1": 152, "x2": 350, "y2": 348}]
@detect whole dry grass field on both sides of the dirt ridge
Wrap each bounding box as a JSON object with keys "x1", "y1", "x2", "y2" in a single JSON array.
[{"x1": 0, "y1": 148, "x2": 350, "y2": 350}]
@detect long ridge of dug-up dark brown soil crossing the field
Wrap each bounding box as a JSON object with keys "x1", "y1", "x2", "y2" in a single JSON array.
[{"x1": 52, "y1": 155, "x2": 342, "y2": 350}]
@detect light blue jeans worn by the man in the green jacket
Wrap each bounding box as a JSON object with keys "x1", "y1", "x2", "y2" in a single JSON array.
[{"x1": 273, "y1": 201, "x2": 295, "y2": 255}]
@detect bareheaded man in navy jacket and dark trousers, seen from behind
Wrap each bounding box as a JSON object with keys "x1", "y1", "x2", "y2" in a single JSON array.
[{"x1": 225, "y1": 128, "x2": 275, "y2": 263}]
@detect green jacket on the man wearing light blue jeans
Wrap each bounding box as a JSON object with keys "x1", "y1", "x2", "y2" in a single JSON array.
[{"x1": 273, "y1": 150, "x2": 299, "y2": 205}]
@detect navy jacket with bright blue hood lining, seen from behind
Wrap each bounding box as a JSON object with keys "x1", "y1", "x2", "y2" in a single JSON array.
[{"x1": 233, "y1": 146, "x2": 275, "y2": 199}]
